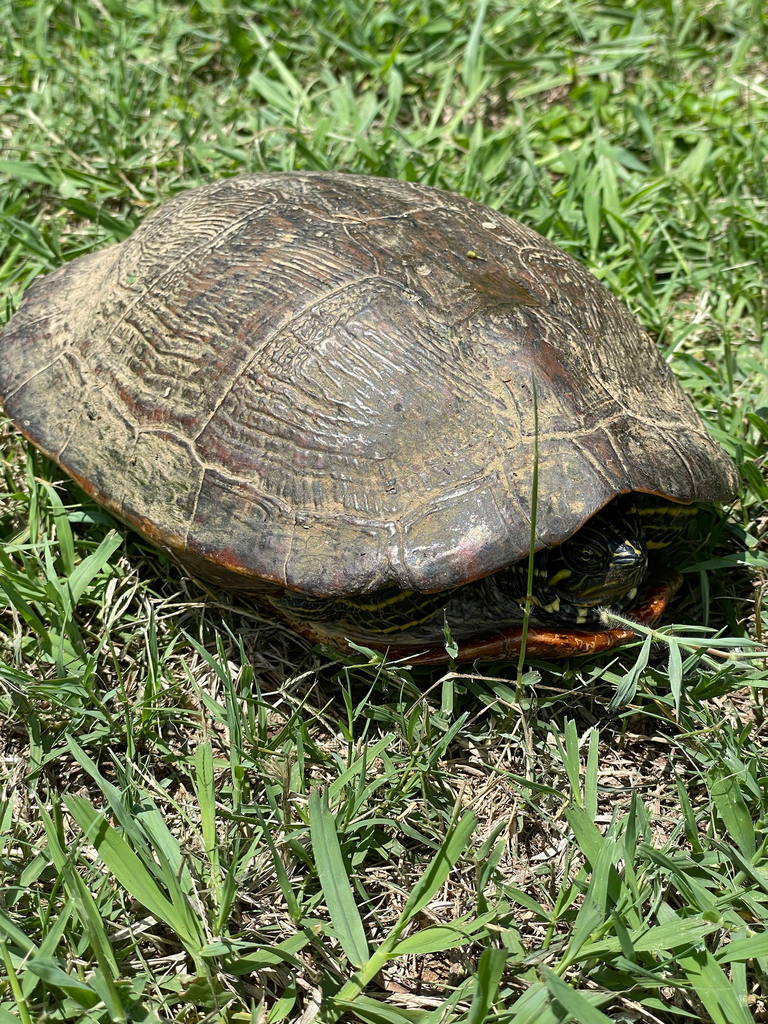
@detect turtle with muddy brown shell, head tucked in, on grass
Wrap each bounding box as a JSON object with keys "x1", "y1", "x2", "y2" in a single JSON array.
[{"x1": 0, "y1": 172, "x2": 737, "y2": 664}]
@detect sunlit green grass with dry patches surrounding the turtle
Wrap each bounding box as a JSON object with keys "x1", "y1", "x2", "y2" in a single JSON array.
[{"x1": 0, "y1": 0, "x2": 768, "y2": 1024}]
